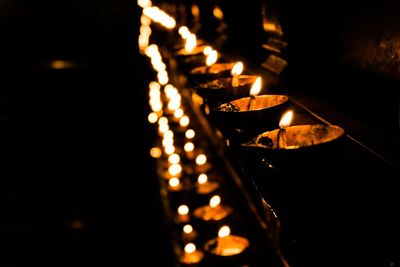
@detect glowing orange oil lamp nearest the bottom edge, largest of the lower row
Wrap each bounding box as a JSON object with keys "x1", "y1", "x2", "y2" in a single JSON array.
[{"x1": 204, "y1": 225, "x2": 250, "y2": 266}]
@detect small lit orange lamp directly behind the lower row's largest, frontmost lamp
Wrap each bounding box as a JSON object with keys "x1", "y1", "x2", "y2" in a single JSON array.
[{"x1": 193, "y1": 195, "x2": 232, "y2": 221}]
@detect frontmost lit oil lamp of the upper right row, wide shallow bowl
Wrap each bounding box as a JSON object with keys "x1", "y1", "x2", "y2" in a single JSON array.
[{"x1": 242, "y1": 111, "x2": 345, "y2": 163}]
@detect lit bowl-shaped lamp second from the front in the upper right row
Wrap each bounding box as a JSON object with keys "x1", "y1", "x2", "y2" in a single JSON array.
[{"x1": 212, "y1": 77, "x2": 289, "y2": 136}]
